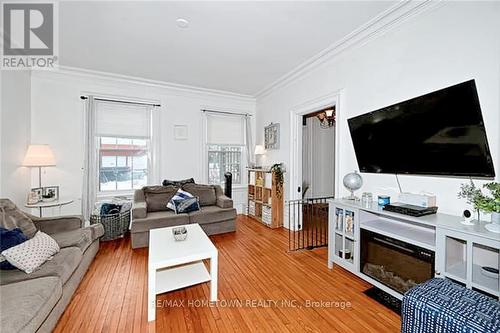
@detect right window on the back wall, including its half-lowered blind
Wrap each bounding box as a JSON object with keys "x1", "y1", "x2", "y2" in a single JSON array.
[{"x1": 206, "y1": 112, "x2": 246, "y2": 185}]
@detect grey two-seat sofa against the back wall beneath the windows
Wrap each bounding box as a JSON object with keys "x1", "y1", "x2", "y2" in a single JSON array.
[{"x1": 130, "y1": 183, "x2": 236, "y2": 249}]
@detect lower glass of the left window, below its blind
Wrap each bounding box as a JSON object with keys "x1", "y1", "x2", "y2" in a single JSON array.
[{"x1": 99, "y1": 137, "x2": 149, "y2": 192}]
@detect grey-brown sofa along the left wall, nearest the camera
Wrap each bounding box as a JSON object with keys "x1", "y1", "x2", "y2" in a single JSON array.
[{"x1": 0, "y1": 199, "x2": 104, "y2": 332}]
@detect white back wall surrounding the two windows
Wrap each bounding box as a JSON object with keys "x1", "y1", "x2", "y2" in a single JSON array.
[{"x1": 31, "y1": 70, "x2": 255, "y2": 214}]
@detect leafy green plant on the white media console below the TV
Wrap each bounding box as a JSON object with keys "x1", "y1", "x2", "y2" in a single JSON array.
[{"x1": 458, "y1": 182, "x2": 500, "y2": 213}]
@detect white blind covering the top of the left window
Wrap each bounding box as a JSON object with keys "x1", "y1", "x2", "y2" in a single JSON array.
[{"x1": 95, "y1": 101, "x2": 151, "y2": 139}]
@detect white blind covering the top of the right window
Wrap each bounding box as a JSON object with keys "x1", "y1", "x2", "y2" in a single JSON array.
[{"x1": 207, "y1": 113, "x2": 245, "y2": 146}]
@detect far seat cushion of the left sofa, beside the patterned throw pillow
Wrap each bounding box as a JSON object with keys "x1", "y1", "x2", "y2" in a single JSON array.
[{"x1": 0, "y1": 247, "x2": 82, "y2": 285}]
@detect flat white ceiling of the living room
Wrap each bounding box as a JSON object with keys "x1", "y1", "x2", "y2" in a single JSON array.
[{"x1": 59, "y1": 1, "x2": 395, "y2": 95}]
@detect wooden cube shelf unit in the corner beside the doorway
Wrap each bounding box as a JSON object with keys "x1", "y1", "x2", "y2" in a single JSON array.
[{"x1": 247, "y1": 169, "x2": 284, "y2": 228}]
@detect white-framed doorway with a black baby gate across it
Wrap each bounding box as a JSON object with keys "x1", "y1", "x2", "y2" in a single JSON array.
[{"x1": 285, "y1": 92, "x2": 340, "y2": 251}]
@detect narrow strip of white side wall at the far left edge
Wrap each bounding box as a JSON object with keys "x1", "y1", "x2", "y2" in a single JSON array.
[{"x1": 0, "y1": 71, "x2": 31, "y2": 209}]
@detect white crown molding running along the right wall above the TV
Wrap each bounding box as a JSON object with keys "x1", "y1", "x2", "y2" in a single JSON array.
[{"x1": 255, "y1": 0, "x2": 441, "y2": 98}]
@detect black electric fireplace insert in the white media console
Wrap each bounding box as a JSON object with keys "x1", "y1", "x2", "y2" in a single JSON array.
[{"x1": 360, "y1": 229, "x2": 435, "y2": 294}]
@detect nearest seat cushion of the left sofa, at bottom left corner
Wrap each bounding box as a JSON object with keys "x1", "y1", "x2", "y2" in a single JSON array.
[{"x1": 0, "y1": 276, "x2": 62, "y2": 332}]
